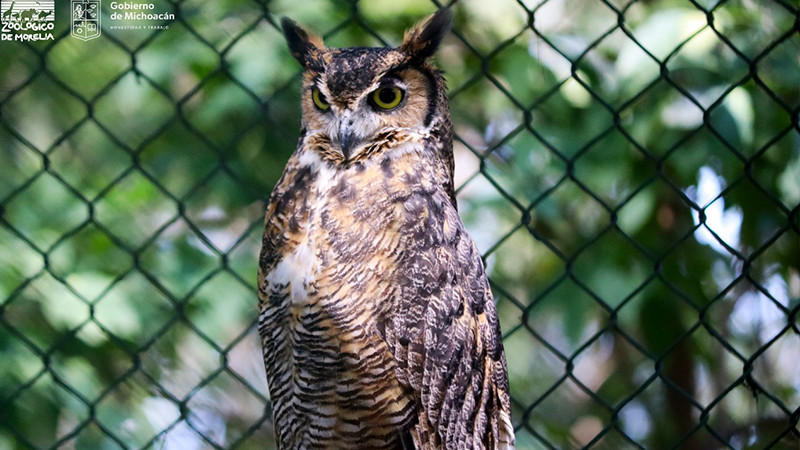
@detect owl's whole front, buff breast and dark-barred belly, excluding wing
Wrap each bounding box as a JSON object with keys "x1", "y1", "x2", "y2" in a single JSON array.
[{"x1": 259, "y1": 143, "x2": 440, "y2": 448}]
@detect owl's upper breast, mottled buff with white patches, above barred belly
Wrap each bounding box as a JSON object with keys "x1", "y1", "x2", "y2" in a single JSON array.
[{"x1": 266, "y1": 152, "x2": 398, "y2": 308}]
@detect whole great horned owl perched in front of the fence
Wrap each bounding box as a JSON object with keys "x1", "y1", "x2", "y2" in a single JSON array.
[{"x1": 258, "y1": 9, "x2": 514, "y2": 449}]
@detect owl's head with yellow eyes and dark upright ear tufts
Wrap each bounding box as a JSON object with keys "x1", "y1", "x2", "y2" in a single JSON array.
[{"x1": 282, "y1": 9, "x2": 451, "y2": 161}]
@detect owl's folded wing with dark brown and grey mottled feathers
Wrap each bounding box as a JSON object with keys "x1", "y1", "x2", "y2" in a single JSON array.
[{"x1": 384, "y1": 191, "x2": 514, "y2": 449}]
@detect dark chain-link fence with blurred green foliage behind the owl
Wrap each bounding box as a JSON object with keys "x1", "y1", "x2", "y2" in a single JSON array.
[{"x1": 0, "y1": 0, "x2": 800, "y2": 449}]
